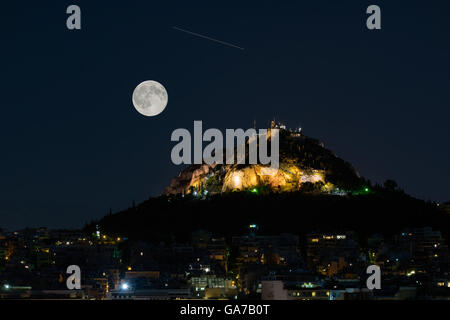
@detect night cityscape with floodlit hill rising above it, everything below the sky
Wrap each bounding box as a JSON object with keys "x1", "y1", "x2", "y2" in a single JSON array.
[{"x1": 0, "y1": 121, "x2": 450, "y2": 300}]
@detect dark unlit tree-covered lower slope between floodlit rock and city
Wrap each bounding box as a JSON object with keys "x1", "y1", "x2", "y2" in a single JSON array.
[{"x1": 86, "y1": 184, "x2": 450, "y2": 242}]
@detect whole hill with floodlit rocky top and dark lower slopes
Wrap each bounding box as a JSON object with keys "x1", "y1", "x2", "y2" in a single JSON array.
[{"x1": 86, "y1": 125, "x2": 450, "y2": 242}]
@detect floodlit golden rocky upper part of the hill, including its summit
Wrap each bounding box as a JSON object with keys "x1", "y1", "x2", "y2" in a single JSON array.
[{"x1": 163, "y1": 129, "x2": 362, "y2": 195}]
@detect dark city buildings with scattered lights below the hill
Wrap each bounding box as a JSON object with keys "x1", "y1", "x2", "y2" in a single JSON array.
[{"x1": 0, "y1": 220, "x2": 450, "y2": 300}]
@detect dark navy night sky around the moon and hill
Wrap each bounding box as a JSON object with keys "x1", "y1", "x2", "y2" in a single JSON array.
[{"x1": 0, "y1": 0, "x2": 450, "y2": 230}]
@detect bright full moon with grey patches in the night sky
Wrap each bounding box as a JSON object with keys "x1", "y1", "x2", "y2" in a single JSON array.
[{"x1": 133, "y1": 80, "x2": 168, "y2": 117}]
